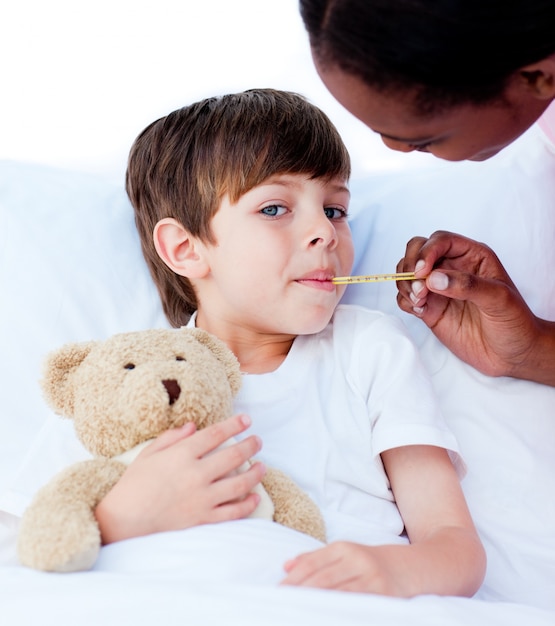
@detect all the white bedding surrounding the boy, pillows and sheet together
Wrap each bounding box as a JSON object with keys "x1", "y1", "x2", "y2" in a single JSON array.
[{"x1": 0, "y1": 119, "x2": 555, "y2": 626}]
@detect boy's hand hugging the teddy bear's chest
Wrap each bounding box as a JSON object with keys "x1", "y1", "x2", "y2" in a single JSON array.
[{"x1": 96, "y1": 415, "x2": 265, "y2": 543}]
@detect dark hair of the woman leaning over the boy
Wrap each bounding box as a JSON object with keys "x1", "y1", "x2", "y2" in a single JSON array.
[{"x1": 300, "y1": 0, "x2": 555, "y2": 113}]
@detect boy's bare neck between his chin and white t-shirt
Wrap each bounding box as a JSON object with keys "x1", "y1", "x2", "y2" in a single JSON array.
[{"x1": 196, "y1": 311, "x2": 295, "y2": 374}]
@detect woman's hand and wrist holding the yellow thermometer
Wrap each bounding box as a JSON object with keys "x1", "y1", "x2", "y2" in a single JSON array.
[{"x1": 397, "y1": 231, "x2": 555, "y2": 385}]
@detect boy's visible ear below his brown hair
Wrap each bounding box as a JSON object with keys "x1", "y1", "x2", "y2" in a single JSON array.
[{"x1": 153, "y1": 217, "x2": 210, "y2": 278}]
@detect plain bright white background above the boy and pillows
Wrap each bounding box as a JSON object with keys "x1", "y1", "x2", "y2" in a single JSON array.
[{"x1": 0, "y1": 0, "x2": 430, "y2": 179}]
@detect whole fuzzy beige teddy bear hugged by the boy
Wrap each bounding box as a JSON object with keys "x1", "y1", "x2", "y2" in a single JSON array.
[{"x1": 17, "y1": 328, "x2": 325, "y2": 572}]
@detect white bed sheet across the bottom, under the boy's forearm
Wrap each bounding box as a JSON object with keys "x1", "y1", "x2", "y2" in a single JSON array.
[{"x1": 0, "y1": 521, "x2": 553, "y2": 626}]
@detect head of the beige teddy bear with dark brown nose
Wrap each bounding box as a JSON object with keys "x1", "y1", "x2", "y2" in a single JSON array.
[{"x1": 41, "y1": 328, "x2": 241, "y2": 456}]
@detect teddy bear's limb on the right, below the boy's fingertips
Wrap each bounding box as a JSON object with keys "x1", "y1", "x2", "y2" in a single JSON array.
[{"x1": 262, "y1": 468, "x2": 326, "y2": 542}]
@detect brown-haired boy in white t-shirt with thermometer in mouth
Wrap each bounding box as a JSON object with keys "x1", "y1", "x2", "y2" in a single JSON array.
[{"x1": 97, "y1": 89, "x2": 485, "y2": 597}]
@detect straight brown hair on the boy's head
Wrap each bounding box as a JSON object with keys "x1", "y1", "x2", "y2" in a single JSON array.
[{"x1": 126, "y1": 89, "x2": 350, "y2": 327}]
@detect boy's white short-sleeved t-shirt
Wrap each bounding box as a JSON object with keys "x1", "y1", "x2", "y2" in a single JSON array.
[{"x1": 192, "y1": 305, "x2": 463, "y2": 544}]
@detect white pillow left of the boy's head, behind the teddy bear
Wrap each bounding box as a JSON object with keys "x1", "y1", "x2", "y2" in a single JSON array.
[{"x1": 0, "y1": 161, "x2": 167, "y2": 508}]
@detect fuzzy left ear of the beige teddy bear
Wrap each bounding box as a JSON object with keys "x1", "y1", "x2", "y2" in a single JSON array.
[{"x1": 40, "y1": 341, "x2": 98, "y2": 417}]
